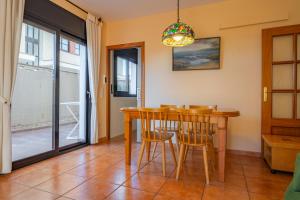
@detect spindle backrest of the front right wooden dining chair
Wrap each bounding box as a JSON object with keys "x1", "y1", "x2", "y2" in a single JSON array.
[{"x1": 177, "y1": 109, "x2": 212, "y2": 146}]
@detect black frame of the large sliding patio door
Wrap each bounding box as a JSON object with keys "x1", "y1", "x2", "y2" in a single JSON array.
[{"x1": 12, "y1": 15, "x2": 91, "y2": 170}]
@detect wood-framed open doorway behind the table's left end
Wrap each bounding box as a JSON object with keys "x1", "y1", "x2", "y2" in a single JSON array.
[{"x1": 106, "y1": 42, "x2": 145, "y2": 140}]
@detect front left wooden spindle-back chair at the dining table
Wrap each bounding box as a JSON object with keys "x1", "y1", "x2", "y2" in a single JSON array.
[{"x1": 138, "y1": 108, "x2": 177, "y2": 176}]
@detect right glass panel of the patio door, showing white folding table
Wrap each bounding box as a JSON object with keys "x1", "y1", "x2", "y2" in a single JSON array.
[{"x1": 59, "y1": 36, "x2": 87, "y2": 147}]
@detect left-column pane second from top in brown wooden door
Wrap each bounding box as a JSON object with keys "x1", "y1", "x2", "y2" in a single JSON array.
[{"x1": 272, "y1": 64, "x2": 294, "y2": 90}]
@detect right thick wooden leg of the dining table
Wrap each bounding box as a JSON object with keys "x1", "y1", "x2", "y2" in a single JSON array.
[{"x1": 217, "y1": 117, "x2": 228, "y2": 182}]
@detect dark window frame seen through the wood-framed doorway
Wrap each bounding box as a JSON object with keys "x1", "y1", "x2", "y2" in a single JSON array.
[{"x1": 113, "y1": 54, "x2": 138, "y2": 97}]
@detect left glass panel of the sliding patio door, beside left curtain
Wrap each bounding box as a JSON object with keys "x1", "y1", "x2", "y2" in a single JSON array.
[{"x1": 11, "y1": 23, "x2": 56, "y2": 161}]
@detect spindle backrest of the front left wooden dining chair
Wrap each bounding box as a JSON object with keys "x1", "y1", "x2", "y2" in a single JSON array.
[{"x1": 139, "y1": 108, "x2": 169, "y2": 140}]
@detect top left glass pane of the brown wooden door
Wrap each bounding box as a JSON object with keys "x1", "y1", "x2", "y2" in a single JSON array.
[{"x1": 273, "y1": 35, "x2": 294, "y2": 61}]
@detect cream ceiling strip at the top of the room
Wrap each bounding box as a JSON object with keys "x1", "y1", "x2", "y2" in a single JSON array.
[{"x1": 71, "y1": 0, "x2": 223, "y2": 21}]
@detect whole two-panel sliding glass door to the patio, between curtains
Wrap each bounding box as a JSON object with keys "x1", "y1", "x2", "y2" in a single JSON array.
[{"x1": 11, "y1": 21, "x2": 89, "y2": 166}]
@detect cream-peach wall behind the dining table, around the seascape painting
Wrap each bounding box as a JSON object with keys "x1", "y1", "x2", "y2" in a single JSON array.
[{"x1": 99, "y1": 0, "x2": 300, "y2": 152}]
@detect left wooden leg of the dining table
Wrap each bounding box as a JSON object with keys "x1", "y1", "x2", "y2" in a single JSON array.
[{"x1": 124, "y1": 113, "x2": 132, "y2": 165}]
